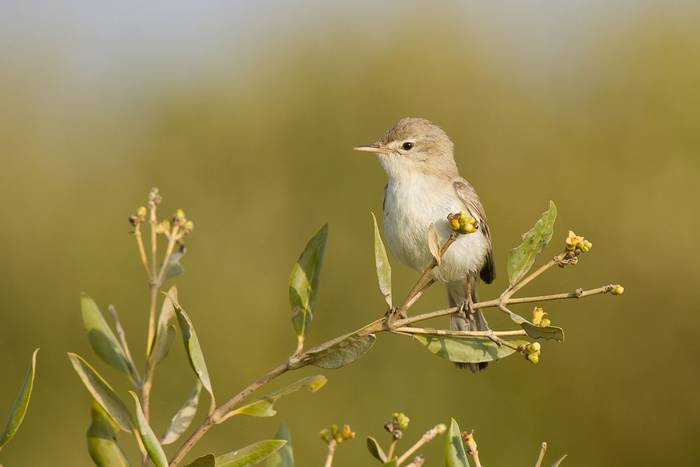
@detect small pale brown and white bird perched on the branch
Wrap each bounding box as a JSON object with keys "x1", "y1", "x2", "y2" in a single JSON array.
[{"x1": 353, "y1": 117, "x2": 496, "y2": 372}]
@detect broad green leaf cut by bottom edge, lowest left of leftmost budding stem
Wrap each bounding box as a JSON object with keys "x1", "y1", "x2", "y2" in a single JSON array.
[{"x1": 87, "y1": 400, "x2": 129, "y2": 467}]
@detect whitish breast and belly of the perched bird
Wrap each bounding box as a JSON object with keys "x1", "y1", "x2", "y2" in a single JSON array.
[{"x1": 384, "y1": 176, "x2": 488, "y2": 282}]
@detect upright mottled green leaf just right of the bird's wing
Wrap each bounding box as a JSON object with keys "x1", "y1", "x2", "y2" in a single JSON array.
[{"x1": 508, "y1": 201, "x2": 557, "y2": 285}]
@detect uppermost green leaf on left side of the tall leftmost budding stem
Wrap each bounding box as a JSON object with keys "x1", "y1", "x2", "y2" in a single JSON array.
[{"x1": 80, "y1": 294, "x2": 132, "y2": 374}]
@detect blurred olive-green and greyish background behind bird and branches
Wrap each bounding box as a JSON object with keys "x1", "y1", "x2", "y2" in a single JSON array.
[{"x1": 0, "y1": 0, "x2": 700, "y2": 466}]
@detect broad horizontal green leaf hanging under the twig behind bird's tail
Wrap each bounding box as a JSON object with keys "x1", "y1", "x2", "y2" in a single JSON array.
[{"x1": 413, "y1": 334, "x2": 527, "y2": 363}]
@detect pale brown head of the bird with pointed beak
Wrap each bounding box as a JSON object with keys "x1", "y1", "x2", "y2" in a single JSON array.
[{"x1": 353, "y1": 117, "x2": 457, "y2": 180}]
